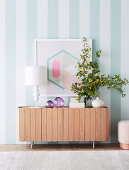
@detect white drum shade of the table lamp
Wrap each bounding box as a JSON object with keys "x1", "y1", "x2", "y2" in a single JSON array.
[{"x1": 25, "y1": 66, "x2": 44, "y2": 86}]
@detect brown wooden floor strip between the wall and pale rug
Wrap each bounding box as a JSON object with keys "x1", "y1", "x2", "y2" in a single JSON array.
[{"x1": 0, "y1": 143, "x2": 122, "y2": 152}]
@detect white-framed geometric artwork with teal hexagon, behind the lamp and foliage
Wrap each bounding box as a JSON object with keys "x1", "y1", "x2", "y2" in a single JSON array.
[{"x1": 35, "y1": 39, "x2": 92, "y2": 96}]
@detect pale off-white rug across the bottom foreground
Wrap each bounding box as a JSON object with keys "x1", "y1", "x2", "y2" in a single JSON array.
[{"x1": 0, "y1": 150, "x2": 129, "y2": 170}]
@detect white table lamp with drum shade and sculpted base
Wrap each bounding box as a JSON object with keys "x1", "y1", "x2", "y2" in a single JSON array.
[{"x1": 25, "y1": 66, "x2": 44, "y2": 108}]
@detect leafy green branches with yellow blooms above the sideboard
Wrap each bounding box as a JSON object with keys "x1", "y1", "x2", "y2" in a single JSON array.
[{"x1": 71, "y1": 37, "x2": 129, "y2": 100}]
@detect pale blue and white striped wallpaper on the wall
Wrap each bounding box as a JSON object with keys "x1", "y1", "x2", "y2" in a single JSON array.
[{"x1": 0, "y1": 0, "x2": 129, "y2": 144}]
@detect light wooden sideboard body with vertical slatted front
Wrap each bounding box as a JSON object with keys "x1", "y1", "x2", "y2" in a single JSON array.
[{"x1": 18, "y1": 107, "x2": 109, "y2": 148}]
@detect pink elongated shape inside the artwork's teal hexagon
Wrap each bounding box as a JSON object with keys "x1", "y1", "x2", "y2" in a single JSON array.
[{"x1": 52, "y1": 60, "x2": 60, "y2": 78}]
